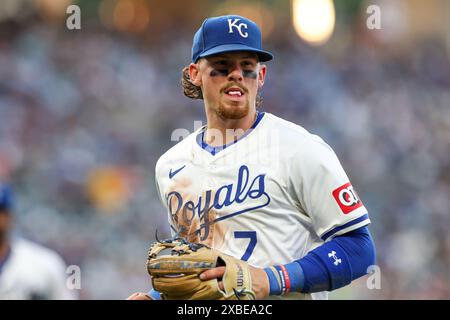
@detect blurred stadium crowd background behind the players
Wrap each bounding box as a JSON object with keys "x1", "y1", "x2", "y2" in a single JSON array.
[{"x1": 0, "y1": 0, "x2": 450, "y2": 299}]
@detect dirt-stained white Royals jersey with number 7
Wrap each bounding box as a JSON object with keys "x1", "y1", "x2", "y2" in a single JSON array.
[{"x1": 156, "y1": 112, "x2": 370, "y2": 299}]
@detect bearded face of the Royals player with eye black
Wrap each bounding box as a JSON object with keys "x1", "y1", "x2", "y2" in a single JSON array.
[{"x1": 191, "y1": 51, "x2": 266, "y2": 119}]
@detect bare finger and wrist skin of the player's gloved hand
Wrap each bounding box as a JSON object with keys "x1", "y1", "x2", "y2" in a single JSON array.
[{"x1": 200, "y1": 265, "x2": 270, "y2": 300}]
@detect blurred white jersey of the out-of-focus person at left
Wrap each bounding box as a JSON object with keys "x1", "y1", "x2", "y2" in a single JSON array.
[{"x1": 0, "y1": 239, "x2": 76, "y2": 300}]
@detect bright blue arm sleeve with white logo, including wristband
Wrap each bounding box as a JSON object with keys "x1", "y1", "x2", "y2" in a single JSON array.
[{"x1": 264, "y1": 227, "x2": 375, "y2": 295}]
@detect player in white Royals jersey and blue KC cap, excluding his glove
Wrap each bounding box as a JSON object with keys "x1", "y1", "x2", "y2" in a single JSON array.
[{"x1": 129, "y1": 15, "x2": 375, "y2": 299}]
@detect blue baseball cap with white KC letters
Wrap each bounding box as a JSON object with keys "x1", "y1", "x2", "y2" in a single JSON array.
[{"x1": 192, "y1": 15, "x2": 273, "y2": 63}]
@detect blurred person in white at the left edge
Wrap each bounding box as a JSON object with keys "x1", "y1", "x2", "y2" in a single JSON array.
[{"x1": 0, "y1": 183, "x2": 77, "y2": 300}]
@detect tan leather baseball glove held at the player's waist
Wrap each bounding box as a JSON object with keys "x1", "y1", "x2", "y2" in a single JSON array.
[{"x1": 147, "y1": 239, "x2": 255, "y2": 300}]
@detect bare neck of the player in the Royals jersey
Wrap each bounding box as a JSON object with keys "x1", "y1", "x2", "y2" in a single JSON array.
[{"x1": 205, "y1": 109, "x2": 257, "y2": 147}]
